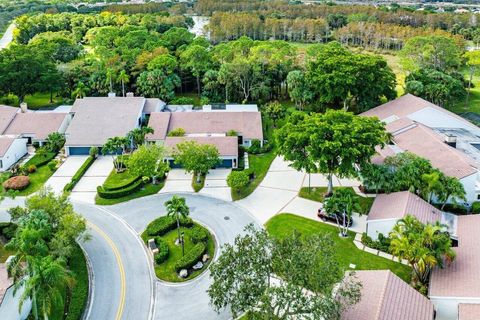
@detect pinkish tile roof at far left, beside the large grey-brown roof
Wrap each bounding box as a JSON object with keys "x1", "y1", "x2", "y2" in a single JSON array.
[{"x1": 3, "y1": 112, "x2": 68, "y2": 140}]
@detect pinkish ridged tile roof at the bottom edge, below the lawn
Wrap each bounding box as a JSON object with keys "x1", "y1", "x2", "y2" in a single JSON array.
[{"x1": 341, "y1": 270, "x2": 434, "y2": 320}]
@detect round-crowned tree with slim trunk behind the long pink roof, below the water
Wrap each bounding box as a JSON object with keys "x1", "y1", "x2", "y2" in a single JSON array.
[{"x1": 180, "y1": 45, "x2": 211, "y2": 97}]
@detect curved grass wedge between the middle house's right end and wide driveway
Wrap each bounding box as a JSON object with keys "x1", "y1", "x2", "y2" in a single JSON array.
[{"x1": 232, "y1": 151, "x2": 275, "y2": 200}]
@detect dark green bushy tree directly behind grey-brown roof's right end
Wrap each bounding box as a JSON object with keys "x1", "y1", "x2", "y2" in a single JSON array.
[{"x1": 137, "y1": 70, "x2": 180, "y2": 101}]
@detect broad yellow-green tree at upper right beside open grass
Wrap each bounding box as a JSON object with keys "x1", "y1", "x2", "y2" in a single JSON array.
[{"x1": 400, "y1": 35, "x2": 461, "y2": 72}]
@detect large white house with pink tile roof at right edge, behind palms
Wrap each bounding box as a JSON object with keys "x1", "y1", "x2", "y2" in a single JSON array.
[{"x1": 362, "y1": 94, "x2": 480, "y2": 203}]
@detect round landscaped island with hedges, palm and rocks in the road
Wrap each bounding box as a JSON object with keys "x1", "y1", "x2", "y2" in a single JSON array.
[{"x1": 142, "y1": 216, "x2": 215, "y2": 282}]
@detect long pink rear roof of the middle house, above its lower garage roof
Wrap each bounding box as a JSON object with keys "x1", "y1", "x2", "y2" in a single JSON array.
[{"x1": 164, "y1": 112, "x2": 263, "y2": 140}]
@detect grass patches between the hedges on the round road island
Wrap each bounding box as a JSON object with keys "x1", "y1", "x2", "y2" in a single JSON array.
[{"x1": 142, "y1": 222, "x2": 215, "y2": 282}]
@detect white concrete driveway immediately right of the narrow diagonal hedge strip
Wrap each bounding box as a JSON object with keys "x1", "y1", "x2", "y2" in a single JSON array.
[{"x1": 70, "y1": 156, "x2": 113, "y2": 203}]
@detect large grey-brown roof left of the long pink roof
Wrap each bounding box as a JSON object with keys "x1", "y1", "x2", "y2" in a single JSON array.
[{"x1": 65, "y1": 97, "x2": 145, "y2": 146}]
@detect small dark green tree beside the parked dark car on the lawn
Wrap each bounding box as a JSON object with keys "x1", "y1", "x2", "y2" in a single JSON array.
[{"x1": 324, "y1": 188, "x2": 362, "y2": 237}]
